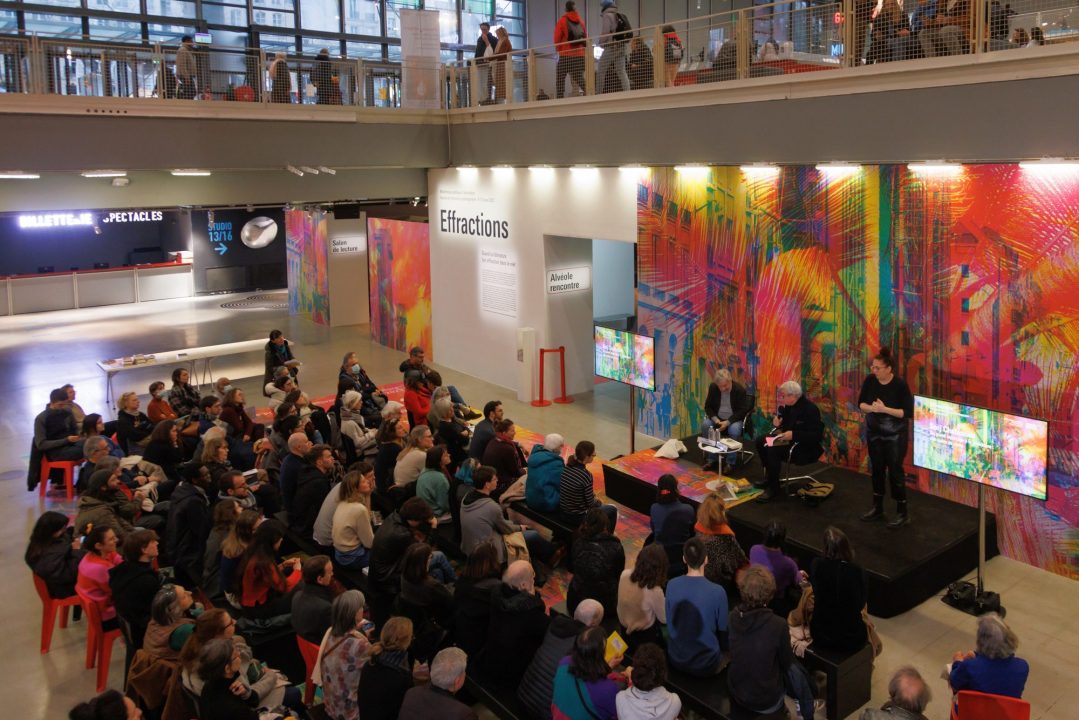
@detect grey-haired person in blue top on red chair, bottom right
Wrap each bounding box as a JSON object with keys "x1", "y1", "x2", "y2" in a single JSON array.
[{"x1": 948, "y1": 612, "x2": 1030, "y2": 697}]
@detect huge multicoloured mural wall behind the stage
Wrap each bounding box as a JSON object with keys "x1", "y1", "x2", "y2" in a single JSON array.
[{"x1": 638, "y1": 165, "x2": 1079, "y2": 578}]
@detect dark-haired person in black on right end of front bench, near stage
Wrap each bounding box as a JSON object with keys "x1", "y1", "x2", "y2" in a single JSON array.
[{"x1": 809, "y1": 527, "x2": 869, "y2": 652}]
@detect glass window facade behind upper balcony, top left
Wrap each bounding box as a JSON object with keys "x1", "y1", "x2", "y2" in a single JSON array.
[{"x1": 0, "y1": 0, "x2": 525, "y2": 62}]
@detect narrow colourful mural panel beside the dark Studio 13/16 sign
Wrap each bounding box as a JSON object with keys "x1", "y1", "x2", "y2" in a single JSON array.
[{"x1": 285, "y1": 210, "x2": 330, "y2": 325}]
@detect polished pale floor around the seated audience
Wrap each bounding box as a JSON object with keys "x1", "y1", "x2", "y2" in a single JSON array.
[{"x1": 0, "y1": 296, "x2": 1079, "y2": 720}]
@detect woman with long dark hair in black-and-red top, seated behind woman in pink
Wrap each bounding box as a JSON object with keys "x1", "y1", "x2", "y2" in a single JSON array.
[{"x1": 237, "y1": 520, "x2": 300, "y2": 619}]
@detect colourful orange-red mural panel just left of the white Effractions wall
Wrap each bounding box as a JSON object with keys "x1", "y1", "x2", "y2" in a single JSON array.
[{"x1": 367, "y1": 218, "x2": 434, "y2": 359}]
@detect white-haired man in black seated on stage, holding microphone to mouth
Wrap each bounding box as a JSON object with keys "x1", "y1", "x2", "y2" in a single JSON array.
[{"x1": 756, "y1": 380, "x2": 823, "y2": 502}]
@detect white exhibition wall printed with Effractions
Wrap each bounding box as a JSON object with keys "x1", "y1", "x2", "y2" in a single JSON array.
[{"x1": 427, "y1": 167, "x2": 639, "y2": 398}]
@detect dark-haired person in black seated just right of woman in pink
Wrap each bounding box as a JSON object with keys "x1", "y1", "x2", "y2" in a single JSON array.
[{"x1": 109, "y1": 530, "x2": 161, "y2": 650}]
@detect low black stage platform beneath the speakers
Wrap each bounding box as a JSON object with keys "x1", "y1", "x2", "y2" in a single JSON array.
[{"x1": 603, "y1": 438, "x2": 998, "y2": 617}]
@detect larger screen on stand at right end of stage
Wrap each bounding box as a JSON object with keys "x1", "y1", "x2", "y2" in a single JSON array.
[{"x1": 914, "y1": 395, "x2": 1049, "y2": 500}]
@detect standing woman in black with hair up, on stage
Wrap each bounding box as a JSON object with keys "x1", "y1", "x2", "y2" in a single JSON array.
[{"x1": 858, "y1": 348, "x2": 914, "y2": 528}]
